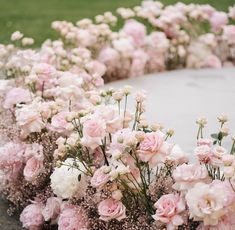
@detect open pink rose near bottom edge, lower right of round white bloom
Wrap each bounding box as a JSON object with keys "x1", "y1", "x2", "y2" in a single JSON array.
[{"x1": 98, "y1": 198, "x2": 126, "y2": 221}]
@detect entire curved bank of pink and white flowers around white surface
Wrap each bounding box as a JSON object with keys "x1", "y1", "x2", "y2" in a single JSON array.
[{"x1": 0, "y1": 0, "x2": 235, "y2": 230}]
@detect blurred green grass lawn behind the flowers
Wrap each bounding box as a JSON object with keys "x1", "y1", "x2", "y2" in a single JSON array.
[{"x1": 0, "y1": 0, "x2": 235, "y2": 46}]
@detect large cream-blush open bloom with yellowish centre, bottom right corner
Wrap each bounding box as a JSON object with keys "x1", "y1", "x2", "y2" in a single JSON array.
[{"x1": 185, "y1": 180, "x2": 234, "y2": 225}]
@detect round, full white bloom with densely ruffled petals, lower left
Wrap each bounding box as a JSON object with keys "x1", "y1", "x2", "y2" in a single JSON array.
[{"x1": 50, "y1": 158, "x2": 87, "y2": 199}]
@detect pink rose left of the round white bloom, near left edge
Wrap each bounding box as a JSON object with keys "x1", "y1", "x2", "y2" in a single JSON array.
[{"x1": 24, "y1": 157, "x2": 44, "y2": 181}]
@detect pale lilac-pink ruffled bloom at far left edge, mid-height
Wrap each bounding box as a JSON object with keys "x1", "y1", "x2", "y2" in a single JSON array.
[{"x1": 3, "y1": 88, "x2": 31, "y2": 109}]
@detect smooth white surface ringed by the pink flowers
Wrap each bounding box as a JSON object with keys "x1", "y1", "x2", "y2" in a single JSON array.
[{"x1": 105, "y1": 68, "x2": 235, "y2": 152}]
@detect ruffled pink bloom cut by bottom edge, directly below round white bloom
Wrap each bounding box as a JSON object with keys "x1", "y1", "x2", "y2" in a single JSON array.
[{"x1": 58, "y1": 206, "x2": 88, "y2": 230}]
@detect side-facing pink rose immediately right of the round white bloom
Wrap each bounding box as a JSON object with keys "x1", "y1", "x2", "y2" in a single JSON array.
[{"x1": 91, "y1": 166, "x2": 110, "y2": 188}]
